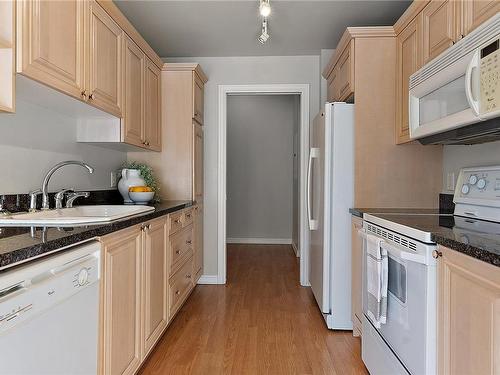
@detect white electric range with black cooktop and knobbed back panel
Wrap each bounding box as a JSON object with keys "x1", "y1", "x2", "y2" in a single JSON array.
[{"x1": 360, "y1": 166, "x2": 500, "y2": 375}]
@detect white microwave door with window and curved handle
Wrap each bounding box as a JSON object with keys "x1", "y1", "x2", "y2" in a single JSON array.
[{"x1": 409, "y1": 47, "x2": 481, "y2": 139}]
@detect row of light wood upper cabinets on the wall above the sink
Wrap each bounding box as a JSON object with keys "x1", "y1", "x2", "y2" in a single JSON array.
[{"x1": 14, "y1": 0, "x2": 162, "y2": 151}]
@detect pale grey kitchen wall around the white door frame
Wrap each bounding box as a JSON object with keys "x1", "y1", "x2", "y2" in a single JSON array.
[{"x1": 166, "y1": 56, "x2": 320, "y2": 275}]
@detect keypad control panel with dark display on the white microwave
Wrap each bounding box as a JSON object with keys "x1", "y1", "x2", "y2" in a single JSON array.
[{"x1": 480, "y1": 39, "x2": 500, "y2": 113}]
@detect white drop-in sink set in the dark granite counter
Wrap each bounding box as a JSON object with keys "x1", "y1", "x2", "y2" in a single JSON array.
[{"x1": 0, "y1": 205, "x2": 154, "y2": 227}]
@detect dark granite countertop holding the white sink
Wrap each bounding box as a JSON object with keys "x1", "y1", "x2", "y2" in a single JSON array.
[{"x1": 0, "y1": 201, "x2": 192, "y2": 272}]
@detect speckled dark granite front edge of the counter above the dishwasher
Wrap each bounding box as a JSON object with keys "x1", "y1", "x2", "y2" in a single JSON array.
[{"x1": 0, "y1": 201, "x2": 192, "y2": 272}]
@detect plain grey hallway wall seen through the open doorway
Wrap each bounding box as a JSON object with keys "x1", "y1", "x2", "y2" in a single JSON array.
[{"x1": 226, "y1": 95, "x2": 298, "y2": 243}]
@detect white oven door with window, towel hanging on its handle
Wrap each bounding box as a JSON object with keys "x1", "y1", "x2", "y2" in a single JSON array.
[{"x1": 363, "y1": 234, "x2": 436, "y2": 374}]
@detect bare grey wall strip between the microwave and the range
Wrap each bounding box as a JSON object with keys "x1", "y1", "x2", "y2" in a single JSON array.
[{"x1": 443, "y1": 142, "x2": 500, "y2": 194}]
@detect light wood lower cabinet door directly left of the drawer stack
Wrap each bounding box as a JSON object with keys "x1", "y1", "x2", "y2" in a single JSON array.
[{"x1": 142, "y1": 217, "x2": 168, "y2": 358}]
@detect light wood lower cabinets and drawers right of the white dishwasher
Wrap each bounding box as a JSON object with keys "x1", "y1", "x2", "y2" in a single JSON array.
[{"x1": 99, "y1": 208, "x2": 195, "y2": 375}]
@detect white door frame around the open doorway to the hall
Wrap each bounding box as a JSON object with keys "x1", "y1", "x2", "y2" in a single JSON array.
[{"x1": 217, "y1": 84, "x2": 310, "y2": 286}]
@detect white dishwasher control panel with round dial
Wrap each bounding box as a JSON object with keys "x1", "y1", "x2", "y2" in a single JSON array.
[{"x1": 0, "y1": 247, "x2": 99, "y2": 334}]
